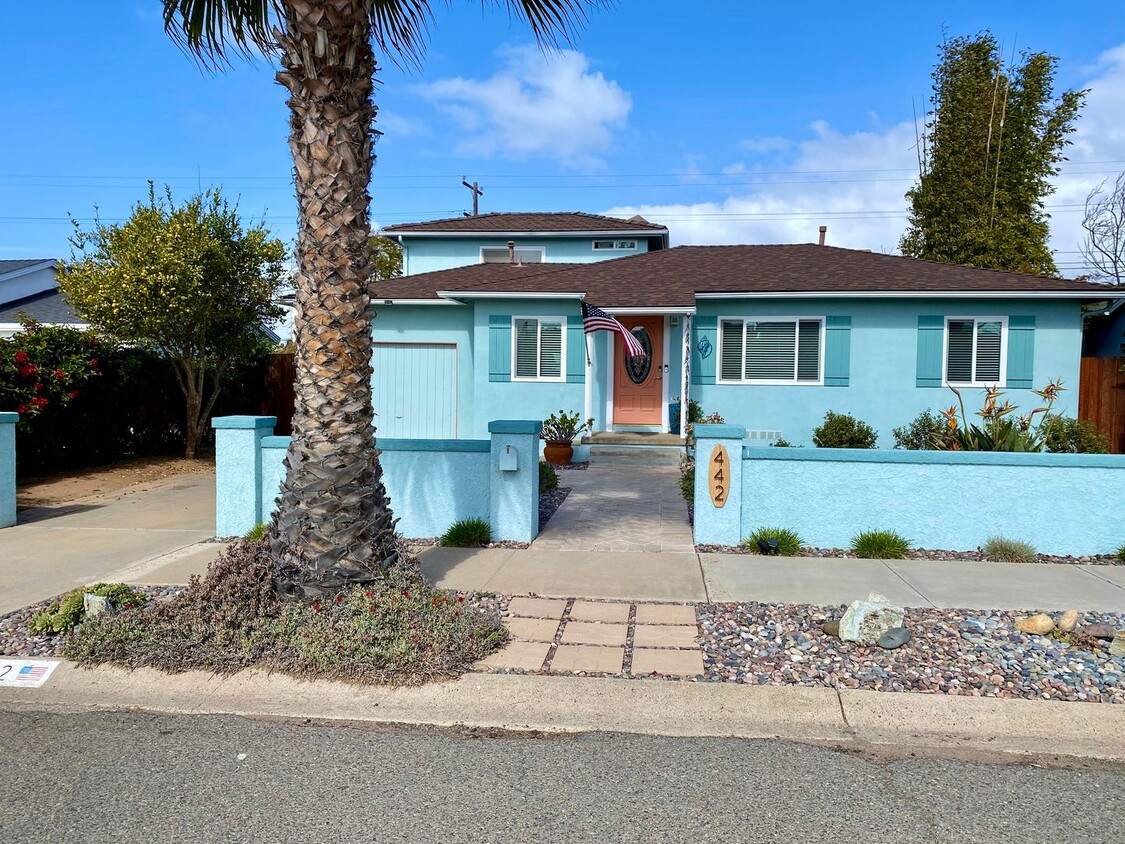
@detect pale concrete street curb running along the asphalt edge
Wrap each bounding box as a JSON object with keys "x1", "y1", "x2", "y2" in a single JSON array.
[{"x1": 0, "y1": 662, "x2": 1125, "y2": 762}]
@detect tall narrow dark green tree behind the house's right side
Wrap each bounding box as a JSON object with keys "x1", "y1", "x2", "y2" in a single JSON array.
[{"x1": 900, "y1": 33, "x2": 1086, "y2": 276}]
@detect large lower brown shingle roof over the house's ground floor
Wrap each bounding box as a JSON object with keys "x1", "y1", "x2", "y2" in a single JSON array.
[{"x1": 376, "y1": 244, "x2": 1107, "y2": 307}]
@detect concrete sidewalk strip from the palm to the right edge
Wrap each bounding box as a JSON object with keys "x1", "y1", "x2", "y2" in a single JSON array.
[{"x1": 421, "y1": 547, "x2": 1125, "y2": 612}]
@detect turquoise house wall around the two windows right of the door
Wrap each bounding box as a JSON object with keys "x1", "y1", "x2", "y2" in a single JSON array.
[{"x1": 691, "y1": 298, "x2": 1082, "y2": 448}]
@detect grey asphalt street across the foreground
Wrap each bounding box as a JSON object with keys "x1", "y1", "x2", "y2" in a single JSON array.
[{"x1": 0, "y1": 710, "x2": 1125, "y2": 844}]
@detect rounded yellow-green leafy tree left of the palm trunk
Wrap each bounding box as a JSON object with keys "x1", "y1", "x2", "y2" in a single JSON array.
[{"x1": 59, "y1": 183, "x2": 286, "y2": 458}]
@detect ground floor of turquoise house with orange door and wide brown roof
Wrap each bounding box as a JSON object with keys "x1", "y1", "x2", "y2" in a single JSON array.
[{"x1": 372, "y1": 244, "x2": 1106, "y2": 448}]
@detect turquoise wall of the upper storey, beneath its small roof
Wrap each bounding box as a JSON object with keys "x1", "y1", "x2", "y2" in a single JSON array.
[{"x1": 403, "y1": 235, "x2": 648, "y2": 276}]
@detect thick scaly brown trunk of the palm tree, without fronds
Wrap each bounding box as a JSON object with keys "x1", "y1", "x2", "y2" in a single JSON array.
[{"x1": 269, "y1": 0, "x2": 397, "y2": 596}]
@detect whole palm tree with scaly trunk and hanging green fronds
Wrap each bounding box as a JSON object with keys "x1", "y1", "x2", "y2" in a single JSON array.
[{"x1": 163, "y1": 0, "x2": 599, "y2": 596}]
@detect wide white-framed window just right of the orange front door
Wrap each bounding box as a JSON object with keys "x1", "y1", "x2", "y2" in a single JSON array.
[{"x1": 719, "y1": 316, "x2": 825, "y2": 384}]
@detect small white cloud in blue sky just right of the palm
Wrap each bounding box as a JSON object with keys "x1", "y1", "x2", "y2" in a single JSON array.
[{"x1": 415, "y1": 46, "x2": 632, "y2": 168}]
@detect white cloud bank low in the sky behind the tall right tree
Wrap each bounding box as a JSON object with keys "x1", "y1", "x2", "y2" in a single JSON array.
[{"x1": 605, "y1": 45, "x2": 1125, "y2": 276}]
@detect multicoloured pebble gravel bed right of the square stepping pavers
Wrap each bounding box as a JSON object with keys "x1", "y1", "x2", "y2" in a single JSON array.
[{"x1": 699, "y1": 603, "x2": 1125, "y2": 703}]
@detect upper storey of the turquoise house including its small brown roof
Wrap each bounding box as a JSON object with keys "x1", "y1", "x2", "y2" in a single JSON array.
[{"x1": 380, "y1": 212, "x2": 668, "y2": 276}]
